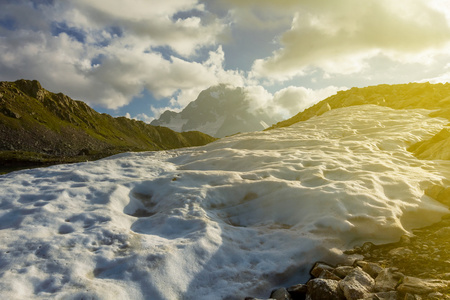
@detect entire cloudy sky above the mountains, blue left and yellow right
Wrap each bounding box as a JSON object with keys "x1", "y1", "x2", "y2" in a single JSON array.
[{"x1": 0, "y1": 0, "x2": 450, "y2": 122}]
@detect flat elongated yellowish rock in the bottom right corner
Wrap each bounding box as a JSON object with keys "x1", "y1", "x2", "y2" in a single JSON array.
[{"x1": 397, "y1": 276, "x2": 450, "y2": 294}]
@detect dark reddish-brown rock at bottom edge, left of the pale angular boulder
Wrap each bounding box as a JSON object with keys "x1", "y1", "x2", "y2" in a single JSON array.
[{"x1": 306, "y1": 278, "x2": 345, "y2": 300}]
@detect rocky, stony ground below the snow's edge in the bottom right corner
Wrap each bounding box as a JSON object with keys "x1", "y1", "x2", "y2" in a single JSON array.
[{"x1": 246, "y1": 217, "x2": 450, "y2": 300}]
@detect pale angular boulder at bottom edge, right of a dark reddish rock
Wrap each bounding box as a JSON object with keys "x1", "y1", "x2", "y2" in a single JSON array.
[{"x1": 339, "y1": 267, "x2": 375, "y2": 300}]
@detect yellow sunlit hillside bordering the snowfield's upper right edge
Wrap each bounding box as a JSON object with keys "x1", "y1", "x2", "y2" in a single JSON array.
[{"x1": 268, "y1": 82, "x2": 450, "y2": 159}]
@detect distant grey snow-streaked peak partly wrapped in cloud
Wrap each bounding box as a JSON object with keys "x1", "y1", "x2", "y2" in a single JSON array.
[{"x1": 150, "y1": 84, "x2": 280, "y2": 138}]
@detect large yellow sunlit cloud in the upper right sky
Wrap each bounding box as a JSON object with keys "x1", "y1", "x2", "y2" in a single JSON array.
[{"x1": 233, "y1": 0, "x2": 450, "y2": 80}]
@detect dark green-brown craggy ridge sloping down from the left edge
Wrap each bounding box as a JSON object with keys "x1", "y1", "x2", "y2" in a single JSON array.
[{"x1": 0, "y1": 80, "x2": 215, "y2": 169}]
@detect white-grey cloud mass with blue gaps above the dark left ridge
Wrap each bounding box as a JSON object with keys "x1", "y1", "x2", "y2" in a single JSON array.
[{"x1": 0, "y1": 0, "x2": 232, "y2": 109}]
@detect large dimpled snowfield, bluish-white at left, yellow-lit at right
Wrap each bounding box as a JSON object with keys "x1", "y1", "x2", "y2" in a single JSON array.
[{"x1": 0, "y1": 105, "x2": 449, "y2": 299}]
